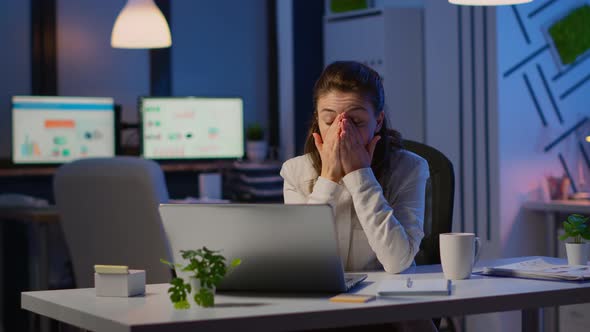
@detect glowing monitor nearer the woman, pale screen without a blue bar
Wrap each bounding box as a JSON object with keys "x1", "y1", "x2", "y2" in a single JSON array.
[{"x1": 139, "y1": 97, "x2": 244, "y2": 160}]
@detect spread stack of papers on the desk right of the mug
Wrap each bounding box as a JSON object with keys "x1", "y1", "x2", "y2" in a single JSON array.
[{"x1": 482, "y1": 258, "x2": 590, "y2": 280}]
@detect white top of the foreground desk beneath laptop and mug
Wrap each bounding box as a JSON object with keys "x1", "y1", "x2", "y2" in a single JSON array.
[{"x1": 21, "y1": 257, "x2": 590, "y2": 332}]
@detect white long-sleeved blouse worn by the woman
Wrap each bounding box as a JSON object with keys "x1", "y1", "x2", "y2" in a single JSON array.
[{"x1": 281, "y1": 150, "x2": 429, "y2": 273}]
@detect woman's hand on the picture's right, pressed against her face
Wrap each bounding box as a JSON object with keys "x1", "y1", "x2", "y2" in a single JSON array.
[{"x1": 340, "y1": 118, "x2": 381, "y2": 174}]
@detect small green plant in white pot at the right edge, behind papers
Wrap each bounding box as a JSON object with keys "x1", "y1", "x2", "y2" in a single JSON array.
[{"x1": 559, "y1": 214, "x2": 590, "y2": 265}]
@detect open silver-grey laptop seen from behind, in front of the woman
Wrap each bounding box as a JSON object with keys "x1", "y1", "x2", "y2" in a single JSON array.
[{"x1": 160, "y1": 204, "x2": 367, "y2": 293}]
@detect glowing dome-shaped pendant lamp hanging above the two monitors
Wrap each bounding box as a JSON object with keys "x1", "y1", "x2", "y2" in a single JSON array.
[{"x1": 111, "y1": 0, "x2": 172, "y2": 48}]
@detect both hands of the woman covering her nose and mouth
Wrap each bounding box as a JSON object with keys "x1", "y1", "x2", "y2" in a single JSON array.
[{"x1": 313, "y1": 113, "x2": 381, "y2": 182}]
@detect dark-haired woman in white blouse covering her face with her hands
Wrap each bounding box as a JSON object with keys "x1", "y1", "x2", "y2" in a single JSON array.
[{"x1": 281, "y1": 62, "x2": 429, "y2": 273}]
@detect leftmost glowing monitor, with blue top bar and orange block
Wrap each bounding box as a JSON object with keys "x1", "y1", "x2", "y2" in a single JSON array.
[{"x1": 12, "y1": 96, "x2": 115, "y2": 164}]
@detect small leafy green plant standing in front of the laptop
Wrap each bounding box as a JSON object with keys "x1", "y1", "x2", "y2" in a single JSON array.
[{"x1": 160, "y1": 247, "x2": 241, "y2": 309}]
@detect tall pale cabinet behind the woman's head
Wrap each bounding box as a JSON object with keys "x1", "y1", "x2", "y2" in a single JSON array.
[{"x1": 324, "y1": 8, "x2": 425, "y2": 142}]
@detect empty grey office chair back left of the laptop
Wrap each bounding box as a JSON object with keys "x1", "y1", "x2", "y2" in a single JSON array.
[{"x1": 53, "y1": 157, "x2": 171, "y2": 287}]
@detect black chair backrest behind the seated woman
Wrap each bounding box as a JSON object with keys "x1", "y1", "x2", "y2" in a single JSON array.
[{"x1": 403, "y1": 140, "x2": 455, "y2": 265}]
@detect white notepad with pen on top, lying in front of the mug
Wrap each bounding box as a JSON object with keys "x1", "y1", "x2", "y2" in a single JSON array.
[{"x1": 377, "y1": 278, "x2": 451, "y2": 296}]
